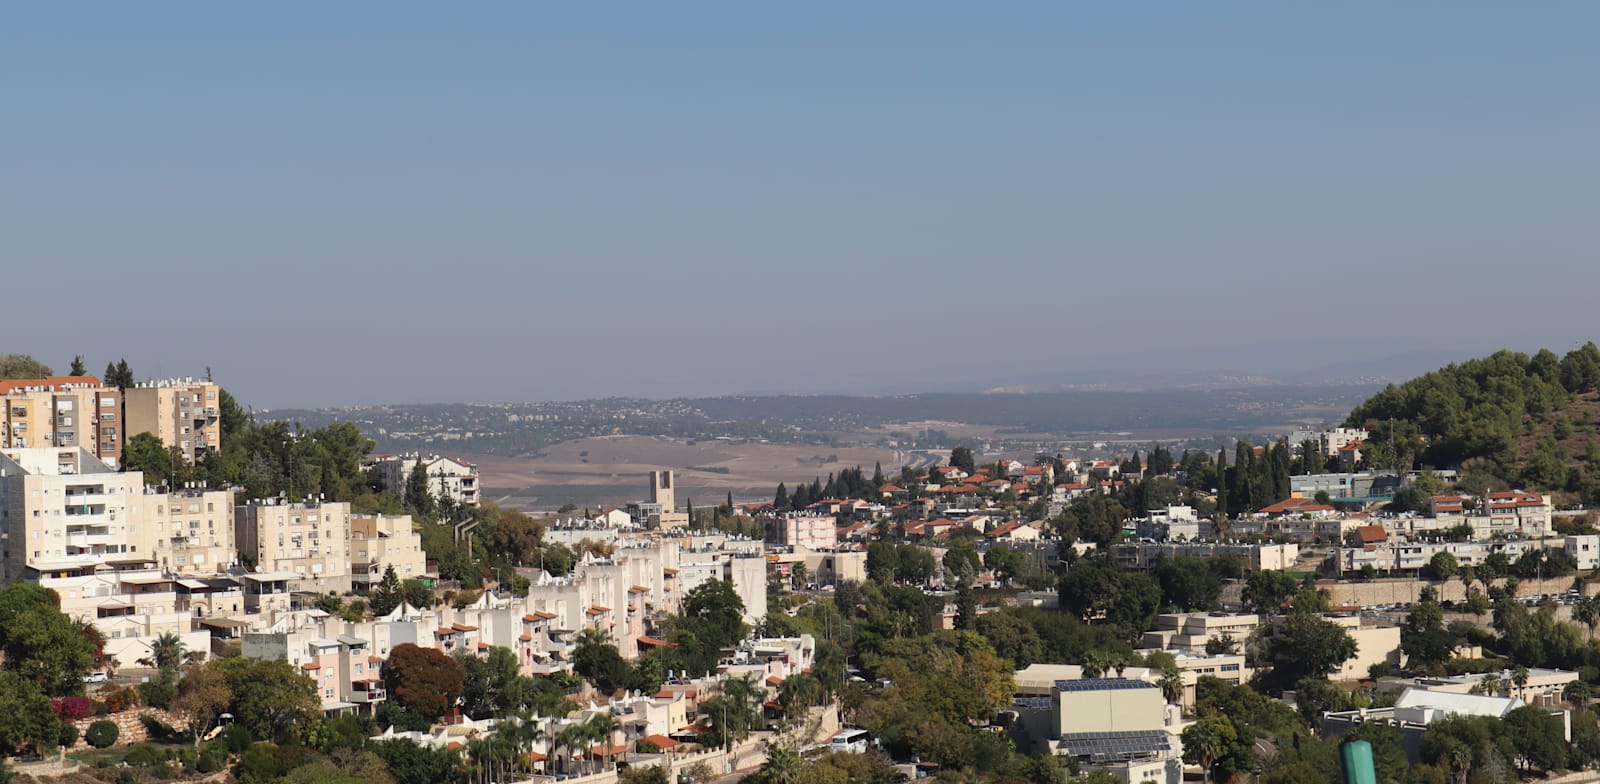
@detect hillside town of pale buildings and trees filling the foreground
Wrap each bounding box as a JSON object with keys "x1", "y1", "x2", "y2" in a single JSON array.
[{"x1": 0, "y1": 355, "x2": 1600, "y2": 784}]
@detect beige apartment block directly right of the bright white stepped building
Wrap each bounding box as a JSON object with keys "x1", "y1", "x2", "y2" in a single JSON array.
[{"x1": 144, "y1": 488, "x2": 238, "y2": 576}]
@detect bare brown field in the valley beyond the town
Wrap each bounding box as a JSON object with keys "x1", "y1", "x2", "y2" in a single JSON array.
[{"x1": 462, "y1": 435, "x2": 904, "y2": 509}]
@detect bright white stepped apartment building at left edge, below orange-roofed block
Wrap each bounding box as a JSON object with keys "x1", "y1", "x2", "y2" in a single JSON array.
[{"x1": 0, "y1": 446, "x2": 154, "y2": 581}]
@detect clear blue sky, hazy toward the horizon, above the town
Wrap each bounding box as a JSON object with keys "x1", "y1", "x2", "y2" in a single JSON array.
[{"x1": 0, "y1": 6, "x2": 1600, "y2": 408}]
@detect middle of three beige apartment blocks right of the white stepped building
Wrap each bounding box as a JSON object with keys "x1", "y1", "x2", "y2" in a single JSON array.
[{"x1": 234, "y1": 498, "x2": 352, "y2": 592}]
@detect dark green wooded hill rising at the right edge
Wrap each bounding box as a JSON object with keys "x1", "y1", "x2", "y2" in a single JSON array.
[{"x1": 1346, "y1": 342, "x2": 1600, "y2": 499}]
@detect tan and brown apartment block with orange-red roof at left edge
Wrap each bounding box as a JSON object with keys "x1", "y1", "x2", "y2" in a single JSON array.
[{"x1": 0, "y1": 376, "x2": 123, "y2": 467}]
